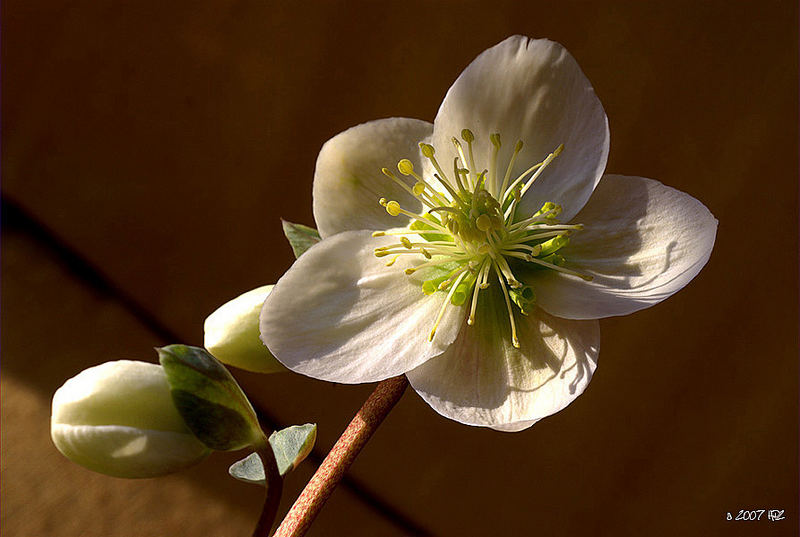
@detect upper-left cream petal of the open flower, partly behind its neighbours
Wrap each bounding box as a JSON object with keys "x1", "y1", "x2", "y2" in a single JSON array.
[{"x1": 314, "y1": 118, "x2": 433, "y2": 238}]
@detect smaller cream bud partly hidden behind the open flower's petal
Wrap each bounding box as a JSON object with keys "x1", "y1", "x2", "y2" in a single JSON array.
[{"x1": 203, "y1": 285, "x2": 286, "y2": 373}]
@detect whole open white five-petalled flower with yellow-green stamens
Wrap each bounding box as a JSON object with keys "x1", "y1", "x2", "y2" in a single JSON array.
[{"x1": 261, "y1": 36, "x2": 716, "y2": 431}]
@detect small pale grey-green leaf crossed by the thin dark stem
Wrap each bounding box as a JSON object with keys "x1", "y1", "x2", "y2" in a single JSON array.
[{"x1": 228, "y1": 423, "x2": 317, "y2": 486}]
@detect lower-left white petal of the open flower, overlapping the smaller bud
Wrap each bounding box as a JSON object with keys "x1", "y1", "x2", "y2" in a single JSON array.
[{"x1": 261, "y1": 231, "x2": 464, "y2": 384}]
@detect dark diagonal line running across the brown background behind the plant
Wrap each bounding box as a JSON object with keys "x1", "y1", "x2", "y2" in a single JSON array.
[{"x1": 0, "y1": 194, "x2": 430, "y2": 537}]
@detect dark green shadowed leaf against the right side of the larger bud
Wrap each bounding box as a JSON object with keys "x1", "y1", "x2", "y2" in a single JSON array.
[{"x1": 156, "y1": 345, "x2": 264, "y2": 451}]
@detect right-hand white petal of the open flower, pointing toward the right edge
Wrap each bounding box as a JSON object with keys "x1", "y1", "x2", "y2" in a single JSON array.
[{"x1": 532, "y1": 175, "x2": 717, "y2": 319}]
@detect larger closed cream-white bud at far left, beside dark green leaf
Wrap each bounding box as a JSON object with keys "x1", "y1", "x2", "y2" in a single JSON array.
[{"x1": 50, "y1": 360, "x2": 210, "y2": 478}]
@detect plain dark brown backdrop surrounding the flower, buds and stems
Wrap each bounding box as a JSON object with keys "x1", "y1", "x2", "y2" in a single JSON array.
[{"x1": 1, "y1": 0, "x2": 798, "y2": 537}]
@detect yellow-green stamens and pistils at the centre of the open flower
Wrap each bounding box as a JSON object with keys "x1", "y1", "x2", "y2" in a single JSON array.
[{"x1": 373, "y1": 129, "x2": 592, "y2": 347}]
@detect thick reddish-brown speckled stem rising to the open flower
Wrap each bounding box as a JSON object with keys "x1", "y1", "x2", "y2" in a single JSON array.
[{"x1": 273, "y1": 375, "x2": 408, "y2": 537}]
